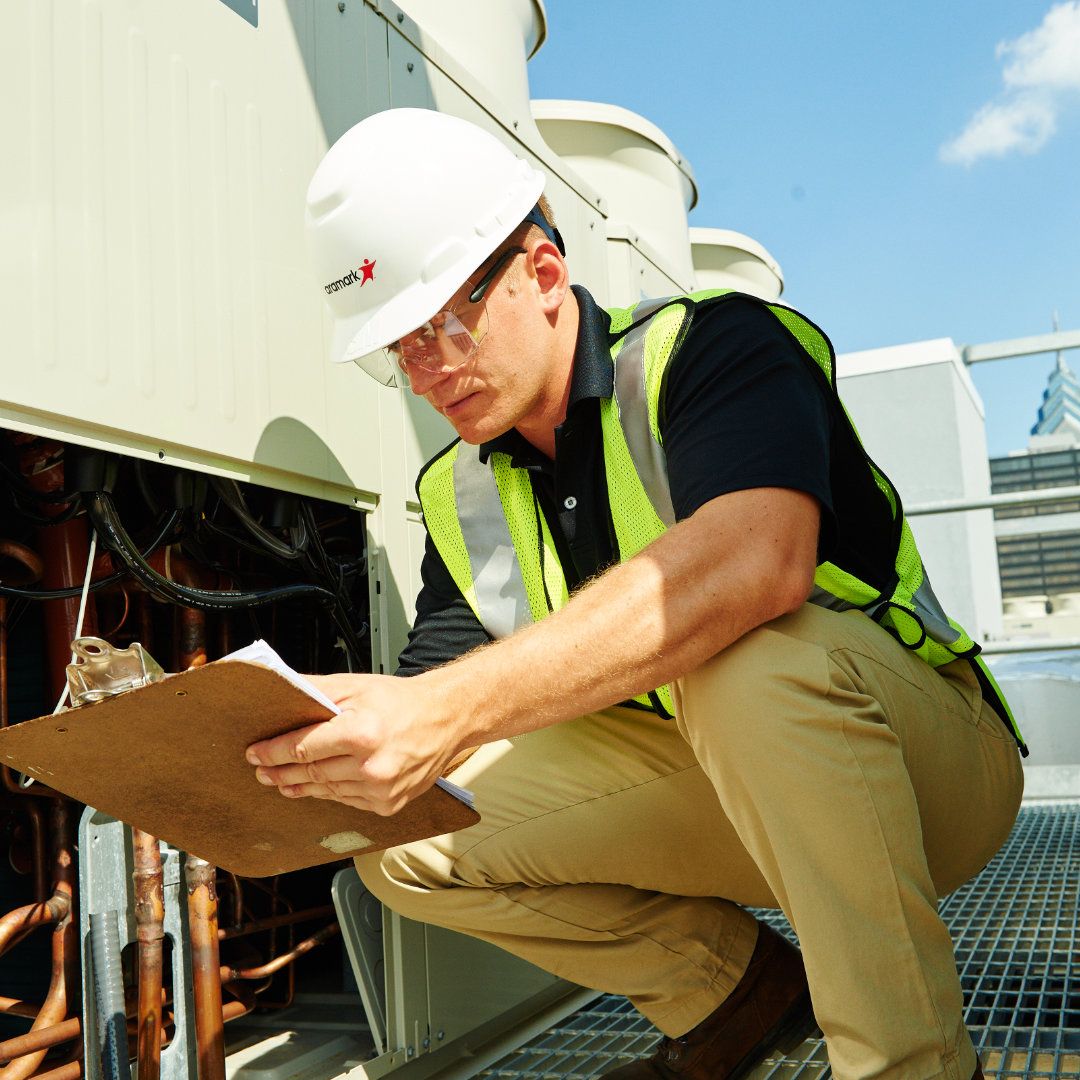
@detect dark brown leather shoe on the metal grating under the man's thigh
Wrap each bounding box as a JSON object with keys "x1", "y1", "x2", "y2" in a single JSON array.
[{"x1": 605, "y1": 923, "x2": 813, "y2": 1080}]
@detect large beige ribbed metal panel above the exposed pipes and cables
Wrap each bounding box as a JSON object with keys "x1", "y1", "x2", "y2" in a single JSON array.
[{"x1": 0, "y1": 0, "x2": 397, "y2": 503}]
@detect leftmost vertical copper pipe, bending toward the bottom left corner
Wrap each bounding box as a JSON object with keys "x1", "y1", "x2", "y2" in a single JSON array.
[{"x1": 0, "y1": 800, "x2": 78, "y2": 1080}]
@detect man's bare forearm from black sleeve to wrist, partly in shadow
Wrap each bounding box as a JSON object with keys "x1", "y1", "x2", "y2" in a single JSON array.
[{"x1": 418, "y1": 488, "x2": 818, "y2": 746}]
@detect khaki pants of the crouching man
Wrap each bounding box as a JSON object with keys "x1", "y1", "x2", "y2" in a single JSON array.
[{"x1": 356, "y1": 605, "x2": 1023, "y2": 1080}]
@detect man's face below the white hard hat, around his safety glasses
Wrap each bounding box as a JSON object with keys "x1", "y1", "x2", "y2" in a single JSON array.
[{"x1": 406, "y1": 252, "x2": 549, "y2": 444}]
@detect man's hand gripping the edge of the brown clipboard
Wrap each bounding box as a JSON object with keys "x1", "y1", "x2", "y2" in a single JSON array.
[{"x1": 247, "y1": 675, "x2": 459, "y2": 815}]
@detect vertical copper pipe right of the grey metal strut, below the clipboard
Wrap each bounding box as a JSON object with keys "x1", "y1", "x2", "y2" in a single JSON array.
[{"x1": 185, "y1": 855, "x2": 225, "y2": 1080}]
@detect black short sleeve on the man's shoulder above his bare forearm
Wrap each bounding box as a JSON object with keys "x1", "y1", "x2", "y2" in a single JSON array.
[{"x1": 660, "y1": 297, "x2": 836, "y2": 557}]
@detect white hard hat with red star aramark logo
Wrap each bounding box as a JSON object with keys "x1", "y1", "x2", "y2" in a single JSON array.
[{"x1": 307, "y1": 109, "x2": 544, "y2": 384}]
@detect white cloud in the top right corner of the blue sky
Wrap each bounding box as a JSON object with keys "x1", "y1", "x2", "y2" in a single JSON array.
[{"x1": 940, "y1": 0, "x2": 1080, "y2": 165}]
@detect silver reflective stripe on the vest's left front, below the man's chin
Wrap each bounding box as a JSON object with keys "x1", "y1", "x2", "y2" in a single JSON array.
[{"x1": 454, "y1": 446, "x2": 532, "y2": 637}]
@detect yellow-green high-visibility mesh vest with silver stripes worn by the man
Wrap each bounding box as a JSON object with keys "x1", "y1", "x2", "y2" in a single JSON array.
[{"x1": 417, "y1": 289, "x2": 1026, "y2": 753}]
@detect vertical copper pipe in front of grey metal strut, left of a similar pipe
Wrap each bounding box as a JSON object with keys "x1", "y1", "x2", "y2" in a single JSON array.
[{"x1": 132, "y1": 828, "x2": 165, "y2": 1080}]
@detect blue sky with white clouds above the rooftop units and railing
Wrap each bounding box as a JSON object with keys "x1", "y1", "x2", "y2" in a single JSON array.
[{"x1": 529, "y1": 0, "x2": 1080, "y2": 455}]
